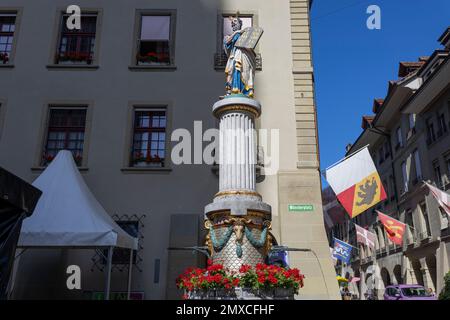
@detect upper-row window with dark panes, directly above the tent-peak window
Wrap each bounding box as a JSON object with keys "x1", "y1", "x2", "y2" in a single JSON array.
[{"x1": 55, "y1": 14, "x2": 97, "y2": 65}]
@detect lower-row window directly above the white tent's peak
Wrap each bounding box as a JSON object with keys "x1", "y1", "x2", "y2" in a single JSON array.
[{"x1": 41, "y1": 107, "x2": 86, "y2": 166}]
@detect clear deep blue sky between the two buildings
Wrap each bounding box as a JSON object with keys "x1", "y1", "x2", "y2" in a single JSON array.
[{"x1": 311, "y1": 0, "x2": 450, "y2": 187}]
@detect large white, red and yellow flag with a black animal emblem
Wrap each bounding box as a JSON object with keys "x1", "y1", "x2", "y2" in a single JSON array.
[{"x1": 325, "y1": 147, "x2": 386, "y2": 218}]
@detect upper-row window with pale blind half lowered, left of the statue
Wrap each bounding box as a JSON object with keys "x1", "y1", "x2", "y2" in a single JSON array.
[{"x1": 136, "y1": 13, "x2": 175, "y2": 66}]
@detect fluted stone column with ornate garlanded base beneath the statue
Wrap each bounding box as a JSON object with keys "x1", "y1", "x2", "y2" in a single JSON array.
[{"x1": 205, "y1": 95, "x2": 271, "y2": 270}]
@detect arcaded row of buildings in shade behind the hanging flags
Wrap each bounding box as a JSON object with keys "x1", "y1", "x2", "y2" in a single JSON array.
[{"x1": 328, "y1": 29, "x2": 450, "y2": 298}]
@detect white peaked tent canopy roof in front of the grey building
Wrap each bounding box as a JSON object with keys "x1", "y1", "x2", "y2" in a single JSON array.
[{"x1": 18, "y1": 150, "x2": 137, "y2": 250}]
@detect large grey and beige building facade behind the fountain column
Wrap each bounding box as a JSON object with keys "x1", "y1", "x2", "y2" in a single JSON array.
[{"x1": 0, "y1": 0, "x2": 338, "y2": 299}]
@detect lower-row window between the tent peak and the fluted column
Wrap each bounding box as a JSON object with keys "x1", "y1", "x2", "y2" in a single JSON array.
[{"x1": 131, "y1": 108, "x2": 167, "y2": 168}]
